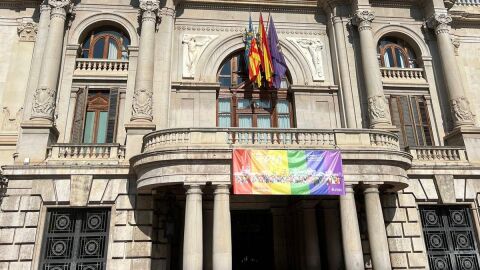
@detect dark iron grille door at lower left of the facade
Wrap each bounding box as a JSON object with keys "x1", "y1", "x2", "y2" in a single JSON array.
[{"x1": 40, "y1": 209, "x2": 110, "y2": 270}]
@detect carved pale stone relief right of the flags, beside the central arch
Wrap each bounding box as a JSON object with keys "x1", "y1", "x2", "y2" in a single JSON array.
[{"x1": 287, "y1": 37, "x2": 325, "y2": 81}]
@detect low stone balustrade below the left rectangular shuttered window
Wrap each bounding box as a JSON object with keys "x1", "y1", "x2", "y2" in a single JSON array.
[{"x1": 47, "y1": 144, "x2": 125, "y2": 163}]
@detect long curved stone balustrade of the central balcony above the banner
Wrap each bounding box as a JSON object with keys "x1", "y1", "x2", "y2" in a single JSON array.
[{"x1": 143, "y1": 128, "x2": 399, "y2": 152}]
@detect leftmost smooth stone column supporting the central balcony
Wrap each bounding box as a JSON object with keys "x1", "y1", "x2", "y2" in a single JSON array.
[{"x1": 183, "y1": 185, "x2": 203, "y2": 270}]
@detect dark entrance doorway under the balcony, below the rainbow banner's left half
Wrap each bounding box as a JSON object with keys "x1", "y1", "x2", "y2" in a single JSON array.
[{"x1": 231, "y1": 210, "x2": 274, "y2": 270}]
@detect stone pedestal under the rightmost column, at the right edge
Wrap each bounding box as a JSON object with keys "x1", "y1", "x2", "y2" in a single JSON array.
[{"x1": 444, "y1": 127, "x2": 480, "y2": 163}]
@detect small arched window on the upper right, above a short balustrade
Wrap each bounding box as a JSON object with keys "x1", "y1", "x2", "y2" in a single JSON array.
[{"x1": 378, "y1": 37, "x2": 418, "y2": 68}]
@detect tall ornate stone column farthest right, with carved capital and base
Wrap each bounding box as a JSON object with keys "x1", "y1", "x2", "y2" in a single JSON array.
[{"x1": 426, "y1": 13, "x2": 474, "y2": 128}]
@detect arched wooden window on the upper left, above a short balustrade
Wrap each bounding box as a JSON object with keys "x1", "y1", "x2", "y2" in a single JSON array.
[{"x1": 81, "y1": 27, "x2": 130, "y2": 60}]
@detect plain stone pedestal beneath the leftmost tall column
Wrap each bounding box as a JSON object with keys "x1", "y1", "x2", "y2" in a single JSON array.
[{"x1": 15, "y1": 120, "x2": 58, "y2": 164}]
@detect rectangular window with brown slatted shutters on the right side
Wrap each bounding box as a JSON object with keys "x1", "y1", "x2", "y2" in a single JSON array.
[{"x1": 389, "y1": 95, "x2": 433, "y2": 148}]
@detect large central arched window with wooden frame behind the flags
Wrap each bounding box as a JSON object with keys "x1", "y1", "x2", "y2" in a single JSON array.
[{"x1": 217, "y1": 51, "x2": 295, "y2": 128}]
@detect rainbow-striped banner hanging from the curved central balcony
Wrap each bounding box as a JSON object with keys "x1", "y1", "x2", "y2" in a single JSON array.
[{"x1": 233, "y1": 149, "x2": 345, "y2": 195}]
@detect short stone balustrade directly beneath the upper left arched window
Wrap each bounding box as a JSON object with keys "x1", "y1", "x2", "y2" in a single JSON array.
[{"x1": 75, "y1": 59, "x2": 129, "y2": 76}]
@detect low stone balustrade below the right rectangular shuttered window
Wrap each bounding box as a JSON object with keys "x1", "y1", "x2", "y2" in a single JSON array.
[{"x1": 407, "y1": 146, "x2": 468, "y2": 164}]
